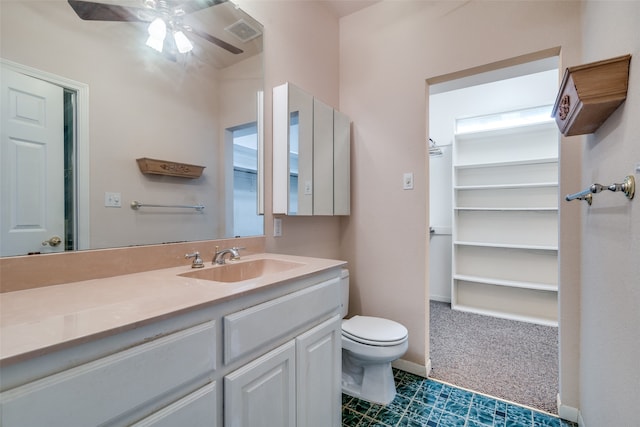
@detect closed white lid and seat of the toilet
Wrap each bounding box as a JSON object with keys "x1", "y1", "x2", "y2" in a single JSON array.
[{"x1": 342, "y1": 316, "x2": 408, "y2": 346}]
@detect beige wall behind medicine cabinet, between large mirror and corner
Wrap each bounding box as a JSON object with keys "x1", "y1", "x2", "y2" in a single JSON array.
[{"x1": 237, "y1": 0, "x2": 343, "y2": 259}]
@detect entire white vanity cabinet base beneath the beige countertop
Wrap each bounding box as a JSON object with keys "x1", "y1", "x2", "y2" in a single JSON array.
[{"x1": 0, "y1": 268, "x2": 341, "y2": 427}]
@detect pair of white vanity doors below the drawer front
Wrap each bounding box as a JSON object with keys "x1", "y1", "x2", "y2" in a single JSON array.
[{"x1": 224, "y1": 315, "x2": 341, "y2": 427}]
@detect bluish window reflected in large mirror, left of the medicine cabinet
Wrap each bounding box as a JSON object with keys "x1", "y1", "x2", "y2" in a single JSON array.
[{"x1": 231, "y1": 122, "x2": 264, "y2": 236}]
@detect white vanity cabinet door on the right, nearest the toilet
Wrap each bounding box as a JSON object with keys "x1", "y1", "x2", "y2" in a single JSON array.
[{"x1": 296, "y1": 315, "x2": 342, "y2": 427}]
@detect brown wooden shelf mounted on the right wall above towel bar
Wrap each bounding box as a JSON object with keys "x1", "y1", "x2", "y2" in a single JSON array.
[{"x1": 553, "y1": 55, "x2": 631, "y2": 136}]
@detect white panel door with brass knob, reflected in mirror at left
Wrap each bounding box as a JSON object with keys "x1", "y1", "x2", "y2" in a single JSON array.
[{"x1": 0, "y1": 67, "x2": 64, "y2": 256}]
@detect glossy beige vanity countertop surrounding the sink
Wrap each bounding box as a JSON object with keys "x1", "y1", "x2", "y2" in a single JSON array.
[{"x1": 0, "y1": 253, "x2": 346, "y2": 364}]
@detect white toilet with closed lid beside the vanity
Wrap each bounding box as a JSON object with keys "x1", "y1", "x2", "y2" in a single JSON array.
[{"x1": 341, "y1": 269, "x2": 409, "y2": 405}]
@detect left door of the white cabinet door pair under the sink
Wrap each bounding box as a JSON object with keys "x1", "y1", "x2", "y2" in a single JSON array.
[{"x1": 224, "y1": 341, "x2": 296, "y2": 427}]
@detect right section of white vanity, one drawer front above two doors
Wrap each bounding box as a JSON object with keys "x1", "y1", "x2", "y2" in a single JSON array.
[{"x1": 224, "y1": 278, "x2": 341, "y2": 427}]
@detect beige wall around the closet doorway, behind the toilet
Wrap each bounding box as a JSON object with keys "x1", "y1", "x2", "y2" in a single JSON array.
[{"x1": 340, "y1": 1, "x2": 581, "y2": 407}]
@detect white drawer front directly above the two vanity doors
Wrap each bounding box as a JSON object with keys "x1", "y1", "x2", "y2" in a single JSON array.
[{"x1": 224, "y1": 278, "x2": 340, "y2": 363}]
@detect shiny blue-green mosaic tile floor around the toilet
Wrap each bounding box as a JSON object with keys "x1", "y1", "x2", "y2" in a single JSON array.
[{"x1": 342, "y1": 369, "x2": 576, "y2": 427}]
